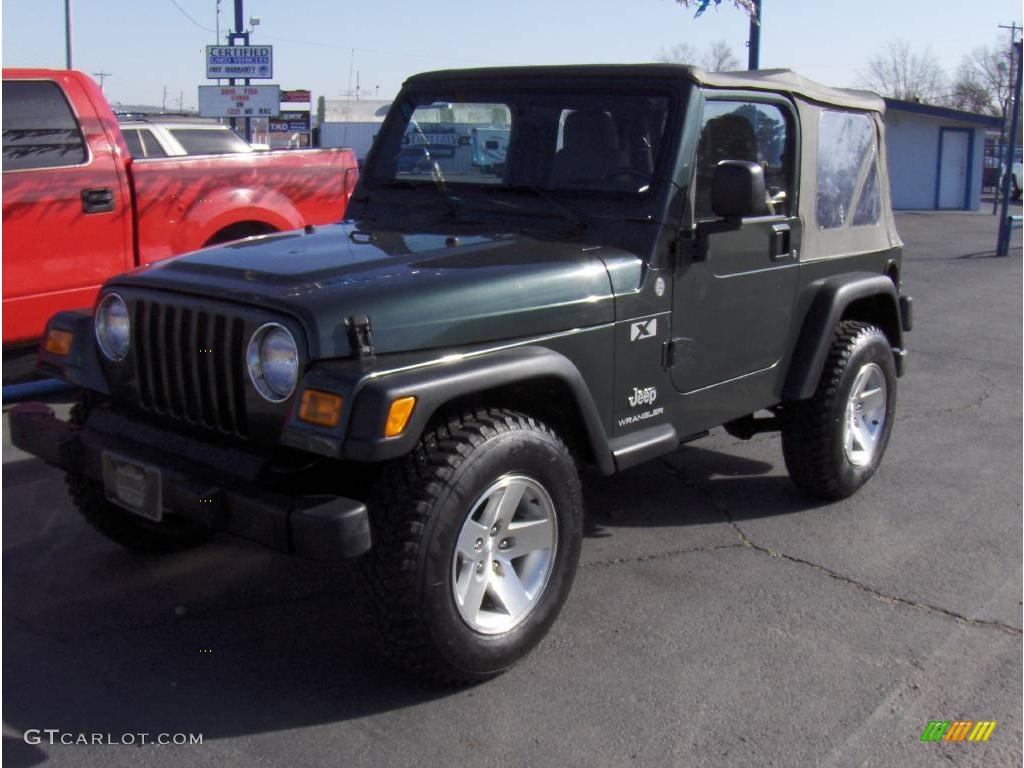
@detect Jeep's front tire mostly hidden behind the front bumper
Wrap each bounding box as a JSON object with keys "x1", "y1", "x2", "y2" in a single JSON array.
[{"x1": 65, "y1": 402, "x2": 208, "y2": 554}]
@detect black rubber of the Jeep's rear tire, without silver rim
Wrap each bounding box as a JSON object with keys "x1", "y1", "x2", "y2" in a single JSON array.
[{"x1": 782, "y1": 321, "x2": 896, "y2": 501}]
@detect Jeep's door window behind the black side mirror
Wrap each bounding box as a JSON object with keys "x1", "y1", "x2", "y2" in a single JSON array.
[{"x1": 695, "y1": 99, "x2": 794, "y2": 219}]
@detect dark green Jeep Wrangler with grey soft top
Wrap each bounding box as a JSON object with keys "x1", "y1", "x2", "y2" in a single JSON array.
[{"x1": 11, "y1": 65, "x2": 911, "y2": 683}]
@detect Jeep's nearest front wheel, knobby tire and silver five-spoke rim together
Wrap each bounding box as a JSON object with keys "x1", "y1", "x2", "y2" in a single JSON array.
[{"x1": 359, "y1": 410, "x2": 583, "y2": 684}]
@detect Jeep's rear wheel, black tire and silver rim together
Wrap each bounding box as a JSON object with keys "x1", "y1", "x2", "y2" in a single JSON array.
[{"x1": 782, "y1": 321, "x2": 896, "y2": 500}]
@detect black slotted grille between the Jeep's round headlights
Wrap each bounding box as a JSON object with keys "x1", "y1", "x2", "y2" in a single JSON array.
[{"x1": 132, "y1": 299, "x2": 247, "y2": 436}]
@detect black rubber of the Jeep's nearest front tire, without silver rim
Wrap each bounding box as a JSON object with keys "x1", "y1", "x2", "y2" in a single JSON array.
[{"x1": 357, "y1": 409, "x2": 583, "y2": 685}]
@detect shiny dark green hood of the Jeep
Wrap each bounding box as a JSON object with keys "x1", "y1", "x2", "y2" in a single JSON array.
[{"x1": 114, "y1": 222, "x2": 614, "y2": 358}]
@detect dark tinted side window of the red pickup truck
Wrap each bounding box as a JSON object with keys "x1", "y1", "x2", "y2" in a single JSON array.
[{"x1": 3, "y1": 80, "x2": 88, "y2": 171}]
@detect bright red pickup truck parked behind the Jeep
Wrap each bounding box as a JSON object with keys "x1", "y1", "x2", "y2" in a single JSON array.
[{"x1": 3, "y1": 70, "x2": 358, "y2": 353}]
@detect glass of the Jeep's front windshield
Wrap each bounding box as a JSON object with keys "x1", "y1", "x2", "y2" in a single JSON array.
[{"x1": 368, "y1": 88, "x2": 674, "y2": 200}]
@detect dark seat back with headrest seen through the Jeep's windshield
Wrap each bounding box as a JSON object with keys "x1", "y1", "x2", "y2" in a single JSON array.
[{"x1": 551, "y1": 110, "x2": 618, "y2": 187}]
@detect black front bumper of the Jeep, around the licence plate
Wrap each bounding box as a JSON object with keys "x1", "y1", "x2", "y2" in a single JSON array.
[{"x1": 9, "y1": 402, "x2": 371, "y2": 559}]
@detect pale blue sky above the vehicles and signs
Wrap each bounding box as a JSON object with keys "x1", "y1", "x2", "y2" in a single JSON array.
[{"x1": 2, "y1": 0, "x2": 1021, "y2": 106}]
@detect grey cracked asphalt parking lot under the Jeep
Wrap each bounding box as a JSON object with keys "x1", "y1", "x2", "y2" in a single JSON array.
[{"x1": 2, "y1": 206, "x2": 1022, "y2": 768}]
